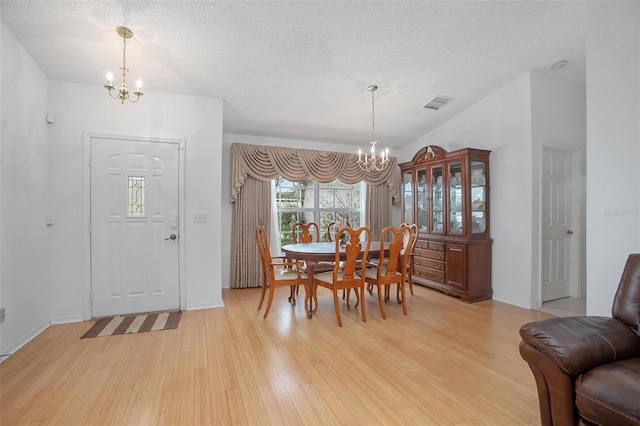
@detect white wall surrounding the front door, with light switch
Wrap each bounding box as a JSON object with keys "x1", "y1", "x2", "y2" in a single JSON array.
[{"x1": 49, "y1": 81, "x2": 223, "y2": 322}]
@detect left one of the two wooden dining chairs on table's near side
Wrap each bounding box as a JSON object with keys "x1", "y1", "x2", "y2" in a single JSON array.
[{"x1": 313, "y1": 227, "x2": 371, "y2": 327}]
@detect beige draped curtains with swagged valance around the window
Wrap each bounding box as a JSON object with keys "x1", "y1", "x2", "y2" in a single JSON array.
[{"x1": 231, "y1": 143, "x2": 400, "y2": 288}]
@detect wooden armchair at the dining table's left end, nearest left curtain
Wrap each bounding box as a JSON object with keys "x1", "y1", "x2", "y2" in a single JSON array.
[{"x1": 256, "y1": 225, "x2": 309, "y2": 318}]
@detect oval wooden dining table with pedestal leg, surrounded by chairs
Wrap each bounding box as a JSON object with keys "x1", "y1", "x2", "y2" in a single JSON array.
[{"x1": 282, "y1": 241, "x2": 389, "y2": 318}]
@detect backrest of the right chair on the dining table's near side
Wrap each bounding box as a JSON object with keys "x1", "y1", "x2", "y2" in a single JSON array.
[{"x1": 378, "y1": 224, "x2": 413, "y2": 283}]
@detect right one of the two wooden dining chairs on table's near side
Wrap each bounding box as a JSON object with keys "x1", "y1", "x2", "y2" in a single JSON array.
[{"x1": 365, "y1": 225, "x2": 412, "y2": 319}]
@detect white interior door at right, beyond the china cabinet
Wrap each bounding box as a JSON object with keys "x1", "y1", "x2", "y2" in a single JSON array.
[{"x1": 542, "y1": 148, "x2": 573, "y2": 302}]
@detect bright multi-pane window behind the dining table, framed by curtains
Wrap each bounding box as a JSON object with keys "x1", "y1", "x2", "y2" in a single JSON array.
[{"x1": 275, "y1": 178, "x2": 365, "y2": 245}]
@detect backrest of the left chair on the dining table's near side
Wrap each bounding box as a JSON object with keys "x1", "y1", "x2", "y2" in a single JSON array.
[{"x1": 333, "y1": 226, "x2": 371, "y2": 286}]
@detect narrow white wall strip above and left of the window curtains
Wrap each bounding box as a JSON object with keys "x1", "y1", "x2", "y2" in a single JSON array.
[{"x1": 222, "y1": 133, "x2": 368, "y2": 288}]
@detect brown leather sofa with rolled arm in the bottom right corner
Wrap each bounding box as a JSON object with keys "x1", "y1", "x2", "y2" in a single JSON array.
[{"x1": 520, "y1": 254, "x2": 640, "y2": 426}]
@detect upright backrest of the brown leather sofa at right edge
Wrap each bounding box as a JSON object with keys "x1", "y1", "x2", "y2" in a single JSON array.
[{"x1": 611, "y1": 254, "x2": 640, "y2": 331}]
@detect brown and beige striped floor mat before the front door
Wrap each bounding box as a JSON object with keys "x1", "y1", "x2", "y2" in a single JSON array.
[{"x1": 81, "y1": 311, "x2": 182, "y2": 339}]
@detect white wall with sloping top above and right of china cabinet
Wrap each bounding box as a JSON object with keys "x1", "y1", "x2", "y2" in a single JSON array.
[{"x1": 400, "y1": 73, "x2": 532, "y2": 307}]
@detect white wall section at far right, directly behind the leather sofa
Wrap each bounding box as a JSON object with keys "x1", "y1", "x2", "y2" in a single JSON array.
[{"x1": 587, "y1": 2, "x2": 640, "y2": 316}]
